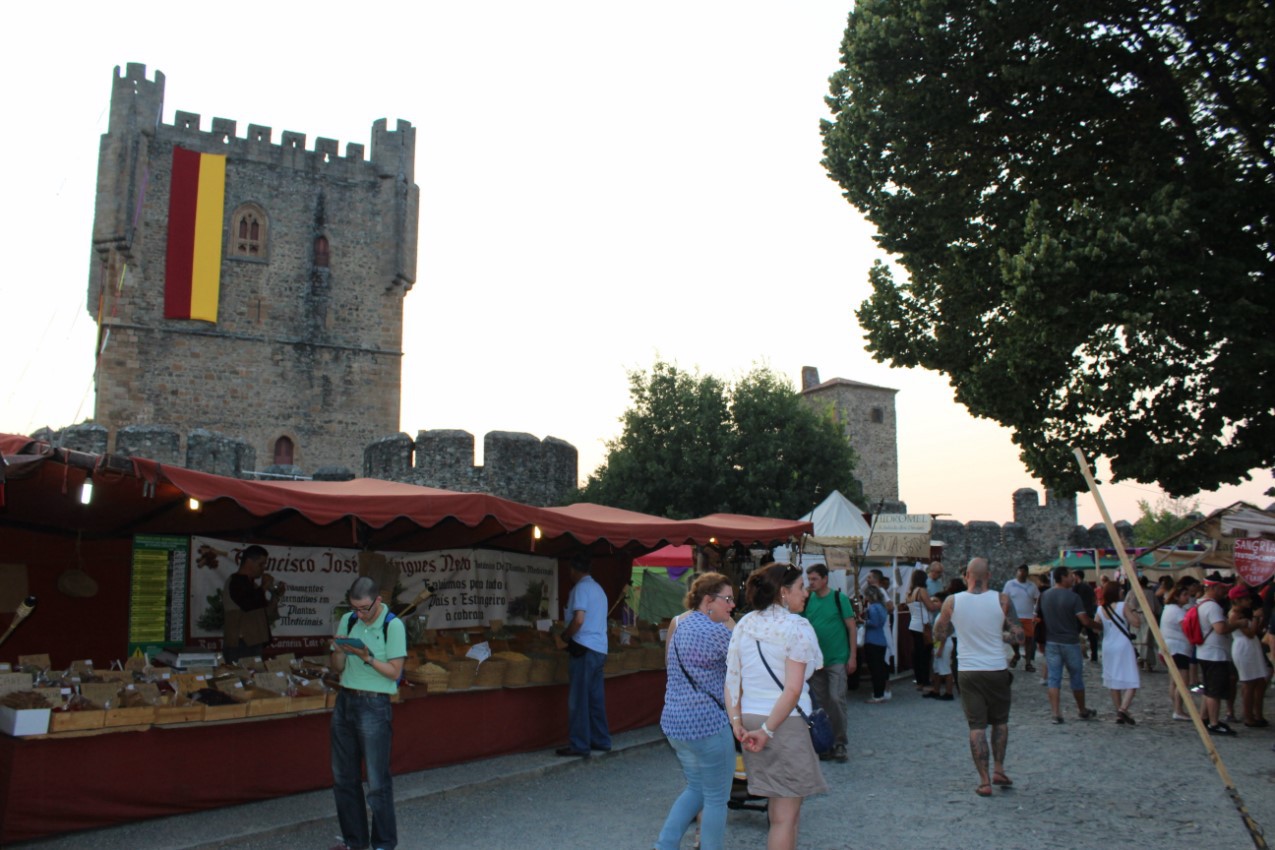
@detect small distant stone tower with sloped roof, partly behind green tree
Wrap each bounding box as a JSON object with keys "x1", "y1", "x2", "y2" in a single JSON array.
[{"x1": 801, "y1": 366, "x2": 899, "y2": 510}]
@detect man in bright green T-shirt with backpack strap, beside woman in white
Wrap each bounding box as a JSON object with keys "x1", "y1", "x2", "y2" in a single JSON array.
[{"x1": 802, "y1": 563, "x2": 858, "y2": 762}]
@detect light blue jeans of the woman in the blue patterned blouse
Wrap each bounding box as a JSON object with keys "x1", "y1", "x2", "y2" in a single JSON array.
[{"x1": 655, "y1": 726, "x2": 734, "y2": 850}]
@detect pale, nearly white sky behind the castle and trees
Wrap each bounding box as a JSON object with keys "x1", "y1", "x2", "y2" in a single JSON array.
[{"x1": 0, "y1": 0, "x2": 1272, "y2": 525}]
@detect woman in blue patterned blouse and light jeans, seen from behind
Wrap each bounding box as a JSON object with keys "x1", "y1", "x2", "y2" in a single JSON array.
[{"x1": 655, "y1": 572, "x2": 734, "y2": 850}]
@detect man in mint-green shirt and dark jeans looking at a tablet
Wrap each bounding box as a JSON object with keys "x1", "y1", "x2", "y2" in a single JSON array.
[{"x1": 330, "y1": 576, "x2": 407, "y2": 850}]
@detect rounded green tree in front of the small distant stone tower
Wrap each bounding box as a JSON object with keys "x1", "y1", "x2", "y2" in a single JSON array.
[{"x1": 580, "y1": 361, "x2": 862, "y2": 519}]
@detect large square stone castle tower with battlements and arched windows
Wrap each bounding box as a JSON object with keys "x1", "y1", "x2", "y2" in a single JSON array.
[{"x1": 88, "y1": 64, "x2": 419, "y2": 469}]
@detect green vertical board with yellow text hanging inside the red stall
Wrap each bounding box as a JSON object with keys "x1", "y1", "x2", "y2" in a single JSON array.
[{"x1": 129, "y1": 535, "x2": 190, "y2": 655}]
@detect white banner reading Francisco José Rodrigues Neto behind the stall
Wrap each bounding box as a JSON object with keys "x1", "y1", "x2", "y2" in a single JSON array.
[{"x1": 189, "y1": 537, "x2": 558, "y2": 649}]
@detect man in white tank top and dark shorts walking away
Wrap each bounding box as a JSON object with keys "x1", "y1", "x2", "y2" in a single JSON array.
[{"x1": 935, "y1": 558, "x2": 1023, "y2": 796}]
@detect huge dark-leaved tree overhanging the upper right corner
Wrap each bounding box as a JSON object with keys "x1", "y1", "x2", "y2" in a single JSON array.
[{"x1": 822, "y1": 0, "x2": 1275, "y2": 496}]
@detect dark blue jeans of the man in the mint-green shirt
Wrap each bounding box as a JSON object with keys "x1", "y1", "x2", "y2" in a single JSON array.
[{"x1": 332, "y1": 691, "x2": 398, "y2": 850}]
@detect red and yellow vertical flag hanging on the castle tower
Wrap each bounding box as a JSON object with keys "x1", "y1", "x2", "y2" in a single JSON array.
[{"x1": 163, "y1": 148, "x2": 226, "y2": 322}]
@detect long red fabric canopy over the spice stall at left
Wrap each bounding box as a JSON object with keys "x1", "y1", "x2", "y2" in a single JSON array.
[{"x1": 0, "y1": 435, "x2": 811, "y2": 659}]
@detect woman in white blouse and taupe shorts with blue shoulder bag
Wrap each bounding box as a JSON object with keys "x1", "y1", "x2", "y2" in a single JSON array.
[{"x1": 725, "y1": 563, "x2": 827, "y2": 850}]
